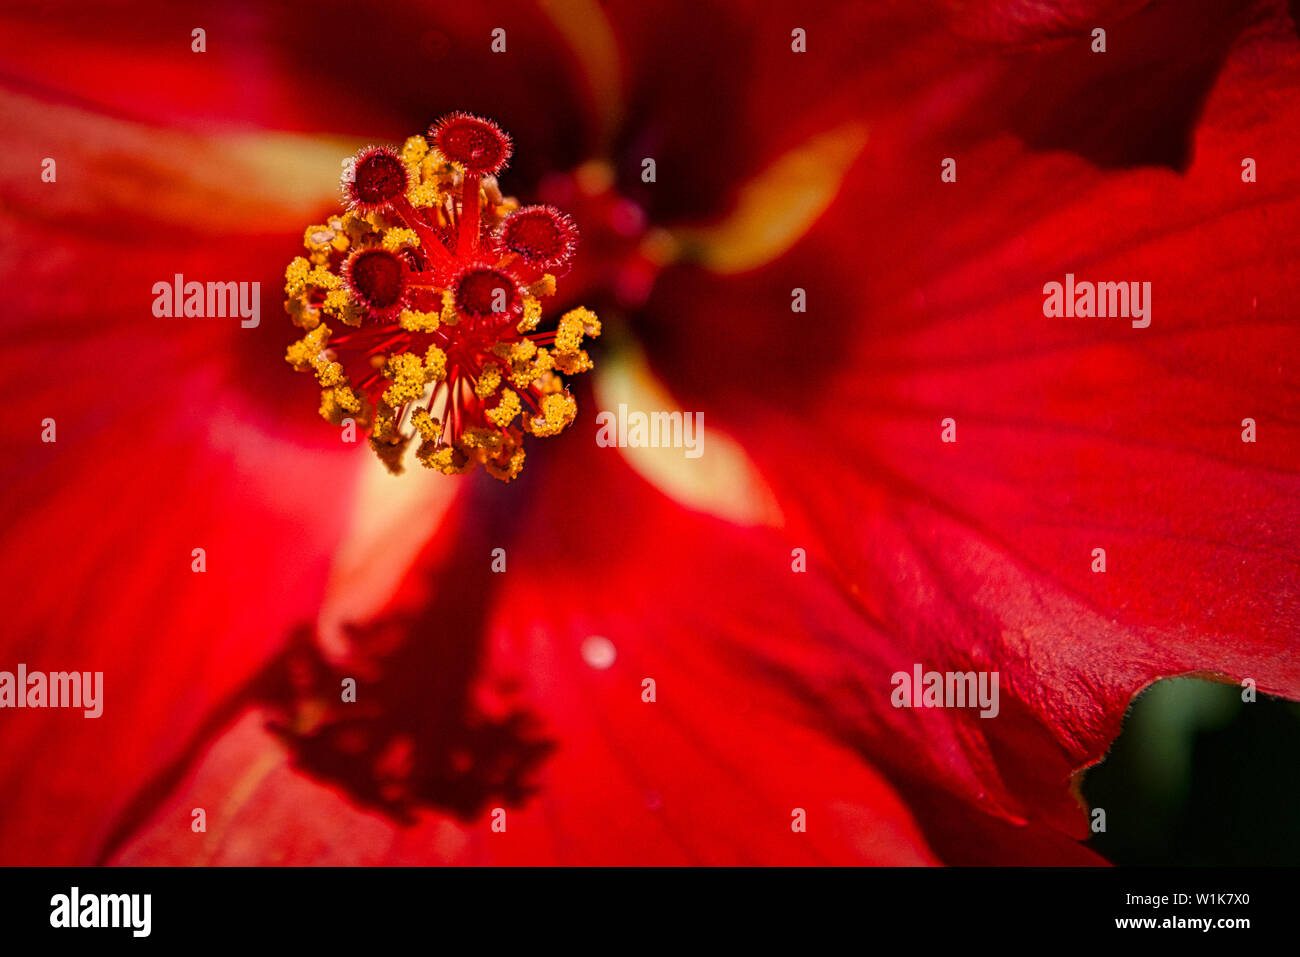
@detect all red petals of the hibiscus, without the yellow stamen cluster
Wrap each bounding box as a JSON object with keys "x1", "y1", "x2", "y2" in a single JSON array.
[{"x1": 0, "y1": 3, "x2": 1300, "y2": 863}]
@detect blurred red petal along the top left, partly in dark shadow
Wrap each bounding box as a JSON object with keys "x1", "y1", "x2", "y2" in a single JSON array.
[{"x1": 0, "y1": 0, "x2": 595, "y2": 164}]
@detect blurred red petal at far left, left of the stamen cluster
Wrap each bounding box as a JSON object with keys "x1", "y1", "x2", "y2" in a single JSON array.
[{"x1": 0, "y1": 95, "x2": 358, "y2": 863}]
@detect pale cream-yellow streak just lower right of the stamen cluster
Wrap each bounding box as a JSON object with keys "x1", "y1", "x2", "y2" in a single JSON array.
[{"x1": 593, "y1": 346, "x2": 784, "y2": 527}]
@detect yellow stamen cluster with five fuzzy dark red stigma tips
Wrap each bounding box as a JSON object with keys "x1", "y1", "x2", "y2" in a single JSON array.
[{"x1": 285, "y1": 113, "x2": 601, "y2": 481}]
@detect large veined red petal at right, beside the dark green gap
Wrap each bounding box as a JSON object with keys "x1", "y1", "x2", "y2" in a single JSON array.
[{"x1": 650, "y1": 23, "x2": 1300, "y2": 852}]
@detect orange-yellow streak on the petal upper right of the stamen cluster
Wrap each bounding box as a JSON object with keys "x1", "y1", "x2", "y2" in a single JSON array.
[{"x1": 675, "y1": 122, "x2": 867, "y2": 273}]
